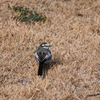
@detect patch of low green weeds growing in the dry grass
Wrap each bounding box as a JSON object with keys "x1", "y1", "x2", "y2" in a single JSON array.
[{"x1": 10, "y1": 6, "x2": 46, "y2": 23}]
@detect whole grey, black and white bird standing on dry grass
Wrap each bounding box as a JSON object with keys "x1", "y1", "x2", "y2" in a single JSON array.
[{"x1": 35, "y1": 42, "x2": 52, "y2": 76}]
